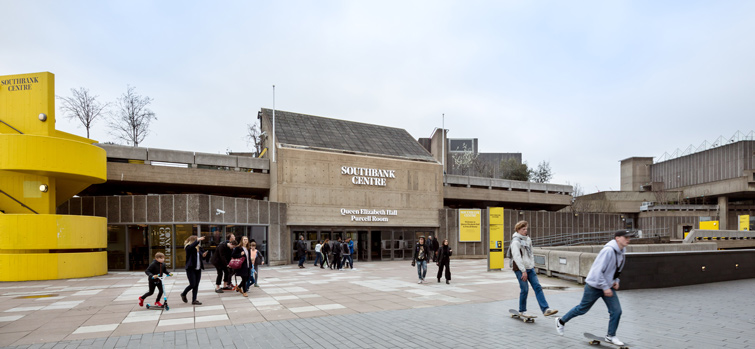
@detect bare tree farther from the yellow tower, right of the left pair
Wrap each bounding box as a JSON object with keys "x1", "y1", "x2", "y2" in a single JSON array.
[{"x1": 110, "y1": 86, "x2": 157, "y2": 147}]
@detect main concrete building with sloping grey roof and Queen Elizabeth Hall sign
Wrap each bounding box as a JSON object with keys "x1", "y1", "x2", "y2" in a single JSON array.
[{"x1": 58, "y1": 109, "x2": 576, "y2": 270}]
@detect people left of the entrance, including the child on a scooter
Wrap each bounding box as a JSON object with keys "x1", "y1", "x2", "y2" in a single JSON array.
[{"x1": 139, "y1": 234, "x2": 265, "y2": 306}]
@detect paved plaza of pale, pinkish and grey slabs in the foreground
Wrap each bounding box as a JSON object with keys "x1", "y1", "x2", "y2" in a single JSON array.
[{"x1": 0, "y1": 260, "x2": 755, "y2": 348}]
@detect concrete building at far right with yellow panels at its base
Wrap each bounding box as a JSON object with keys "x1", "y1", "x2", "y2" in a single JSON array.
[{"x1": 569, "y1": 140, "x2": 755, "y2": 239}]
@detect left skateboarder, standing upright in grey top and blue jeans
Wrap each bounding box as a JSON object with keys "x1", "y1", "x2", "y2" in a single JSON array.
[{"x1": 509, "y1": 221, "x2": 558, "y2": 316}]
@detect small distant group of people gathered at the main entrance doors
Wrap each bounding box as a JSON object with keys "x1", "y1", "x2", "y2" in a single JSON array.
[{"x1": 296, "y1": 235, "x2": 354, "y2": 270}]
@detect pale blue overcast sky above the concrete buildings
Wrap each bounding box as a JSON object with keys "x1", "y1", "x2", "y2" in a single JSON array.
[{"x1": 0, "y1": 0, "x2": 755, "y2": 193}]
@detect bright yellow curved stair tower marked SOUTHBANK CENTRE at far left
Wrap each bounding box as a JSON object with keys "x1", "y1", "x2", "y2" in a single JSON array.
[{"x1": 0, "y1": 72, "x2": 107, "y2": 281}]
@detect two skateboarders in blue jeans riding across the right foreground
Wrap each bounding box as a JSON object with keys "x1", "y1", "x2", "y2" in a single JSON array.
[{"x1": 510, "y1": 221, "x2": 632, "y2": 346}]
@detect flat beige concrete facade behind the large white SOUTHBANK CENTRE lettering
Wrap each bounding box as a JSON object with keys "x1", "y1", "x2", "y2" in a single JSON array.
[{"x1": 277, "y1": 148, "x2": 443, "y2": 228}]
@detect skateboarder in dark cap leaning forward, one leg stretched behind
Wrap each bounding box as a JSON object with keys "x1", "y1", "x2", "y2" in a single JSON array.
[{"x1": 556, "y1": 230, "x2": 633, "y2": 346}]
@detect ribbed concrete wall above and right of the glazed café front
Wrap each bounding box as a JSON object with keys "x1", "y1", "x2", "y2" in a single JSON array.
[{"x1": 58, "y1": 194, "x2": 291, "y2": 265}]
